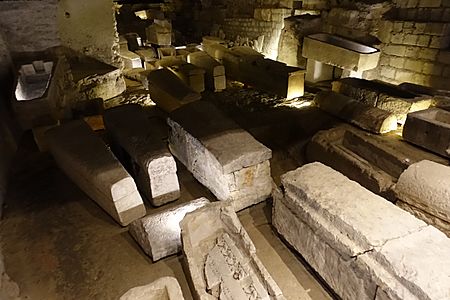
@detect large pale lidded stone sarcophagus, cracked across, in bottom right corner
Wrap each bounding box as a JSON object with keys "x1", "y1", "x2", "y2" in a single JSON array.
[{"x1": 273, "y1": 163, "x2": 450, "y2": 300}]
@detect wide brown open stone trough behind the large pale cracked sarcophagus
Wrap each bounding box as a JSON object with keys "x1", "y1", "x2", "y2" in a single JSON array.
[{"x1": 306, "y1": 125, "x2": 448, "y2": 201}]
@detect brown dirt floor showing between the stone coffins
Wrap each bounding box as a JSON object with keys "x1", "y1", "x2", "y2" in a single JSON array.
[{"x1": 0, "y1": 85, "x2": 335, "y2": 300}]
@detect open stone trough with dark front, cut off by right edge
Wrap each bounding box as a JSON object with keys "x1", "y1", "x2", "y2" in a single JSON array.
[{"x1": 403, "y1": 108, "x2": 450, "y2": 157}]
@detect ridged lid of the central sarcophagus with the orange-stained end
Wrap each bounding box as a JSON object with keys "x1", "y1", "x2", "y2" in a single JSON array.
[{"x1": 169, "y1": 100, "x2": 272, "y2": 173}]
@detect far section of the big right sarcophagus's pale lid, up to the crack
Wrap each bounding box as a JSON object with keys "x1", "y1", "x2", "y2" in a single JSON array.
[{"x1": 281, "y1": 162, "x2": 427, "y2": 249}]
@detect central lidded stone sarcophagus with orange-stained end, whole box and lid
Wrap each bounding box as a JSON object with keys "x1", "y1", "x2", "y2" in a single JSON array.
[{"x1": 168, "y1": 101, "x2": 272, "y2": 211}]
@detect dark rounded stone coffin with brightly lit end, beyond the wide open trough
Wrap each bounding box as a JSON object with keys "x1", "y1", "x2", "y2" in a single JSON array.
[{"x1": 314, "y1": 92, "x2": 397, "y2": 133}]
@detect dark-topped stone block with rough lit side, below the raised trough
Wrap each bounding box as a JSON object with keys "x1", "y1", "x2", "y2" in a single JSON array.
[{"x1": 333, "y1": 78, "x2": 431, "y2": 124}]
